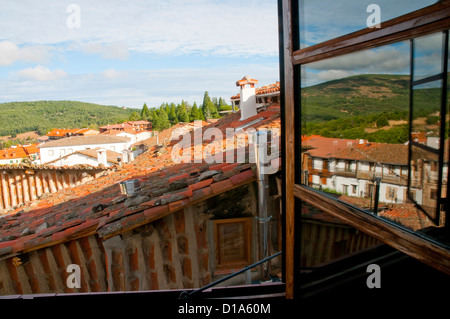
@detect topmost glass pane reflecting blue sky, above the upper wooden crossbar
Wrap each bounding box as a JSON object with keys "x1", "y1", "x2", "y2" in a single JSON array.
[{"x1": 299, "y1": 0, "x2": 437, "y2": 48}]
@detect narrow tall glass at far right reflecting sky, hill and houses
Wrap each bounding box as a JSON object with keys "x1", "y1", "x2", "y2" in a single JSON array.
[{"x1": 409, "y1": 33, "x2": 446, "y2": 232}]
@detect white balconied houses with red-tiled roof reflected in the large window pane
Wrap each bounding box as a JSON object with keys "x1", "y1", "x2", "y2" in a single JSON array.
[{"x1": 303, "y1": 136, "x2": 416, "y2": 208}]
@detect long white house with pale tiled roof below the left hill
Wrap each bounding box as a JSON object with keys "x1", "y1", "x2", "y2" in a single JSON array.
[{"x1": 38, "y1": 134, "x2": 132, "y2": 164}]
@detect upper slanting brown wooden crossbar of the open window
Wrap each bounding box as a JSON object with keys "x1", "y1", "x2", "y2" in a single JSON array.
[{"x1": 293, "y1": 1, "x2": 450, "y2": 65}]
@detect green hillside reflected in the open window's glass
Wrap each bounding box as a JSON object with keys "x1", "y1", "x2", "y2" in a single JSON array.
[{"x1": 301, "y1": 74, "x2": 440, "y2": 143}]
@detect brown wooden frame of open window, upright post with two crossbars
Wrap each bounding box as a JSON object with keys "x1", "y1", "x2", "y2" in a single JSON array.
[{"x1": 278, "y1": 0, "x2": 450, "y2": 298}]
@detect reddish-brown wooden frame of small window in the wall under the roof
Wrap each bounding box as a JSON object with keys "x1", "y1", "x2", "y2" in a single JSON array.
[{"x1": 213, "y1": 217, "x2": 252, "y2": 271}]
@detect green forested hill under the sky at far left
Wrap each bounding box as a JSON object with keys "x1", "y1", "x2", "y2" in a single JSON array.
[{"x1": 0, "y1": 101, "x2": 136, "y2": 136}]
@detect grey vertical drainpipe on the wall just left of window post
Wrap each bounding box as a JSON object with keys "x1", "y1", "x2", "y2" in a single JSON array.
[{"x1": 253, "y1": 130, "x2": 272, "y2": 282}]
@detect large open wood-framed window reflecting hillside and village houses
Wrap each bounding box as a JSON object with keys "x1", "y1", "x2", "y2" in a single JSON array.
[{"x1": 280, "y1": 0, "x2": 450, "y2": 298}]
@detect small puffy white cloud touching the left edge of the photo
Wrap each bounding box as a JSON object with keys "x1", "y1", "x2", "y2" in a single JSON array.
[{"x1": 0, "y1": 41, "x2": 49, "y2": 66}]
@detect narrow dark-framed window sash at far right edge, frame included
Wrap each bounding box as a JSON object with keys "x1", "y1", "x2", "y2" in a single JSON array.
[{"x1": 408, "y1": 30, "x2": 449, "y2": 227}]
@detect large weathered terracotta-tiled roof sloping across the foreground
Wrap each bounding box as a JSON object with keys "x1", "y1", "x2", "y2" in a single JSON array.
[{"x1": 0, "y1": 105, "x2": 280, "y2": 256}]
